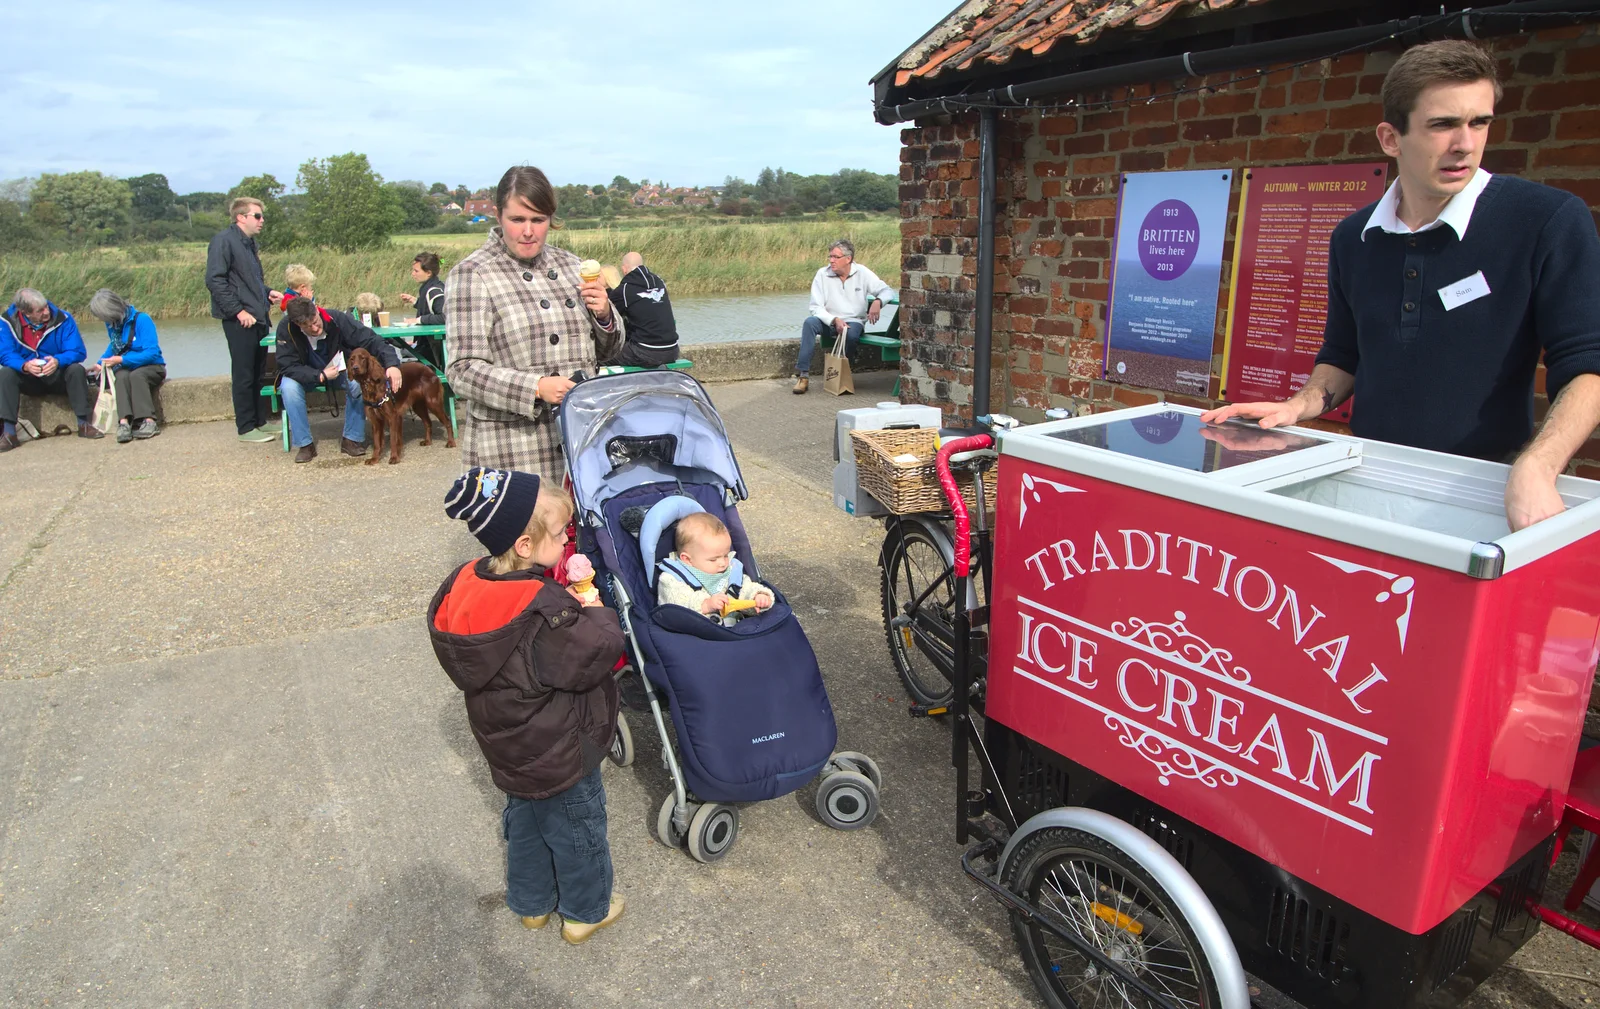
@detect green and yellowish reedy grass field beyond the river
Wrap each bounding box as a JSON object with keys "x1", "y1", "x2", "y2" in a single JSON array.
[{"x1": 0, "y1": 217, "x2": 899, "y2": 318}]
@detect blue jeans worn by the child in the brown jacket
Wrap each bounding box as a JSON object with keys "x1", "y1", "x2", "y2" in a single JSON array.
[{"x1": 501, "y1": 768, "x2": 611, "y2": 924}]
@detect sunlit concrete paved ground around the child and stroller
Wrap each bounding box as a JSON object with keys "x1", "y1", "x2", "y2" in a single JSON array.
[{"x1": 0, "y1": 374, "x2": 1600, "y2": 1007}]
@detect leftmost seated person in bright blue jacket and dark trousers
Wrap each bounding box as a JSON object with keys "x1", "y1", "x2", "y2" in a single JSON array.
[{"x1": 0, "y1": 288, "x2": 106, "y2": 453}]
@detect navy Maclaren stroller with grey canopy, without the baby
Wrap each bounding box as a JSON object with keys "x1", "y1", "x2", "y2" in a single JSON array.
[{"x1": 562, "y1": 371, "x2": 883, "y2": 862}]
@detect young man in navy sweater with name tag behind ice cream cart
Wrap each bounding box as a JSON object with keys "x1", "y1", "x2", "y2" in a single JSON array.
[{"x1": 1202, "y1": 42, "x2": 1600, "y2": 529}]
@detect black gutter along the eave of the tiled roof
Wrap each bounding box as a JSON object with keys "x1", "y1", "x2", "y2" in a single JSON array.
[{"x1": 874, "y1": 0, "x2": 1600, "y2": 125}]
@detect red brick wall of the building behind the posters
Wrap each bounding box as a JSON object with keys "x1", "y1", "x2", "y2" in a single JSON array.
[{"x1": 899, "y1": 26, "x2": 1600, "y2": 478}]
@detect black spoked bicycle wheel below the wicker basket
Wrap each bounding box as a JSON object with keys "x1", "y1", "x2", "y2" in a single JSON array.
[{"x1": 882, "y1": 523, "x2": 957, "y2": 705}]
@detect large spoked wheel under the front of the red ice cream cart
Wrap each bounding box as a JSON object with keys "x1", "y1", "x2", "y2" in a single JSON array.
[{"x1": 1002, "y1": 827, "x2": 1221, "y2": 1009}]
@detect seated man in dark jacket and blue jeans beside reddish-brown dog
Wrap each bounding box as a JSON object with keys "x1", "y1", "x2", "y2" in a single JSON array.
[{"x1": 277, "y1": 297, "x2": 400, "y2": 462}]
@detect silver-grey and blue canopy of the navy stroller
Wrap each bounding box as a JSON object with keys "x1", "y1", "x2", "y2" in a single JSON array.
[{"x1": 562, "y1": 371, "x2": 749, "y2": 521}]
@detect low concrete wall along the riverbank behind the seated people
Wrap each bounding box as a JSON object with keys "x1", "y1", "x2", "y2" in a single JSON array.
[{"x1": 21, "y1": 339, "x2": 899, "y2": 432}]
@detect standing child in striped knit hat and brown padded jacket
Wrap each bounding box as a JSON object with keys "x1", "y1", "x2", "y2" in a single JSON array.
[{"x1": 427, "y1": 469, "x2": 622, "y2": 943}]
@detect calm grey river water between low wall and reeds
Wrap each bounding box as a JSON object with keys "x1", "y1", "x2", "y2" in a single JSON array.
[{"x1": 139, "y1": 294, "x2": 810, "y2": 379}]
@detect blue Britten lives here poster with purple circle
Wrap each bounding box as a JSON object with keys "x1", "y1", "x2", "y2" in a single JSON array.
[{"x1": 1106, "y1": 169, "x2": 1234, "y2": 397}]
